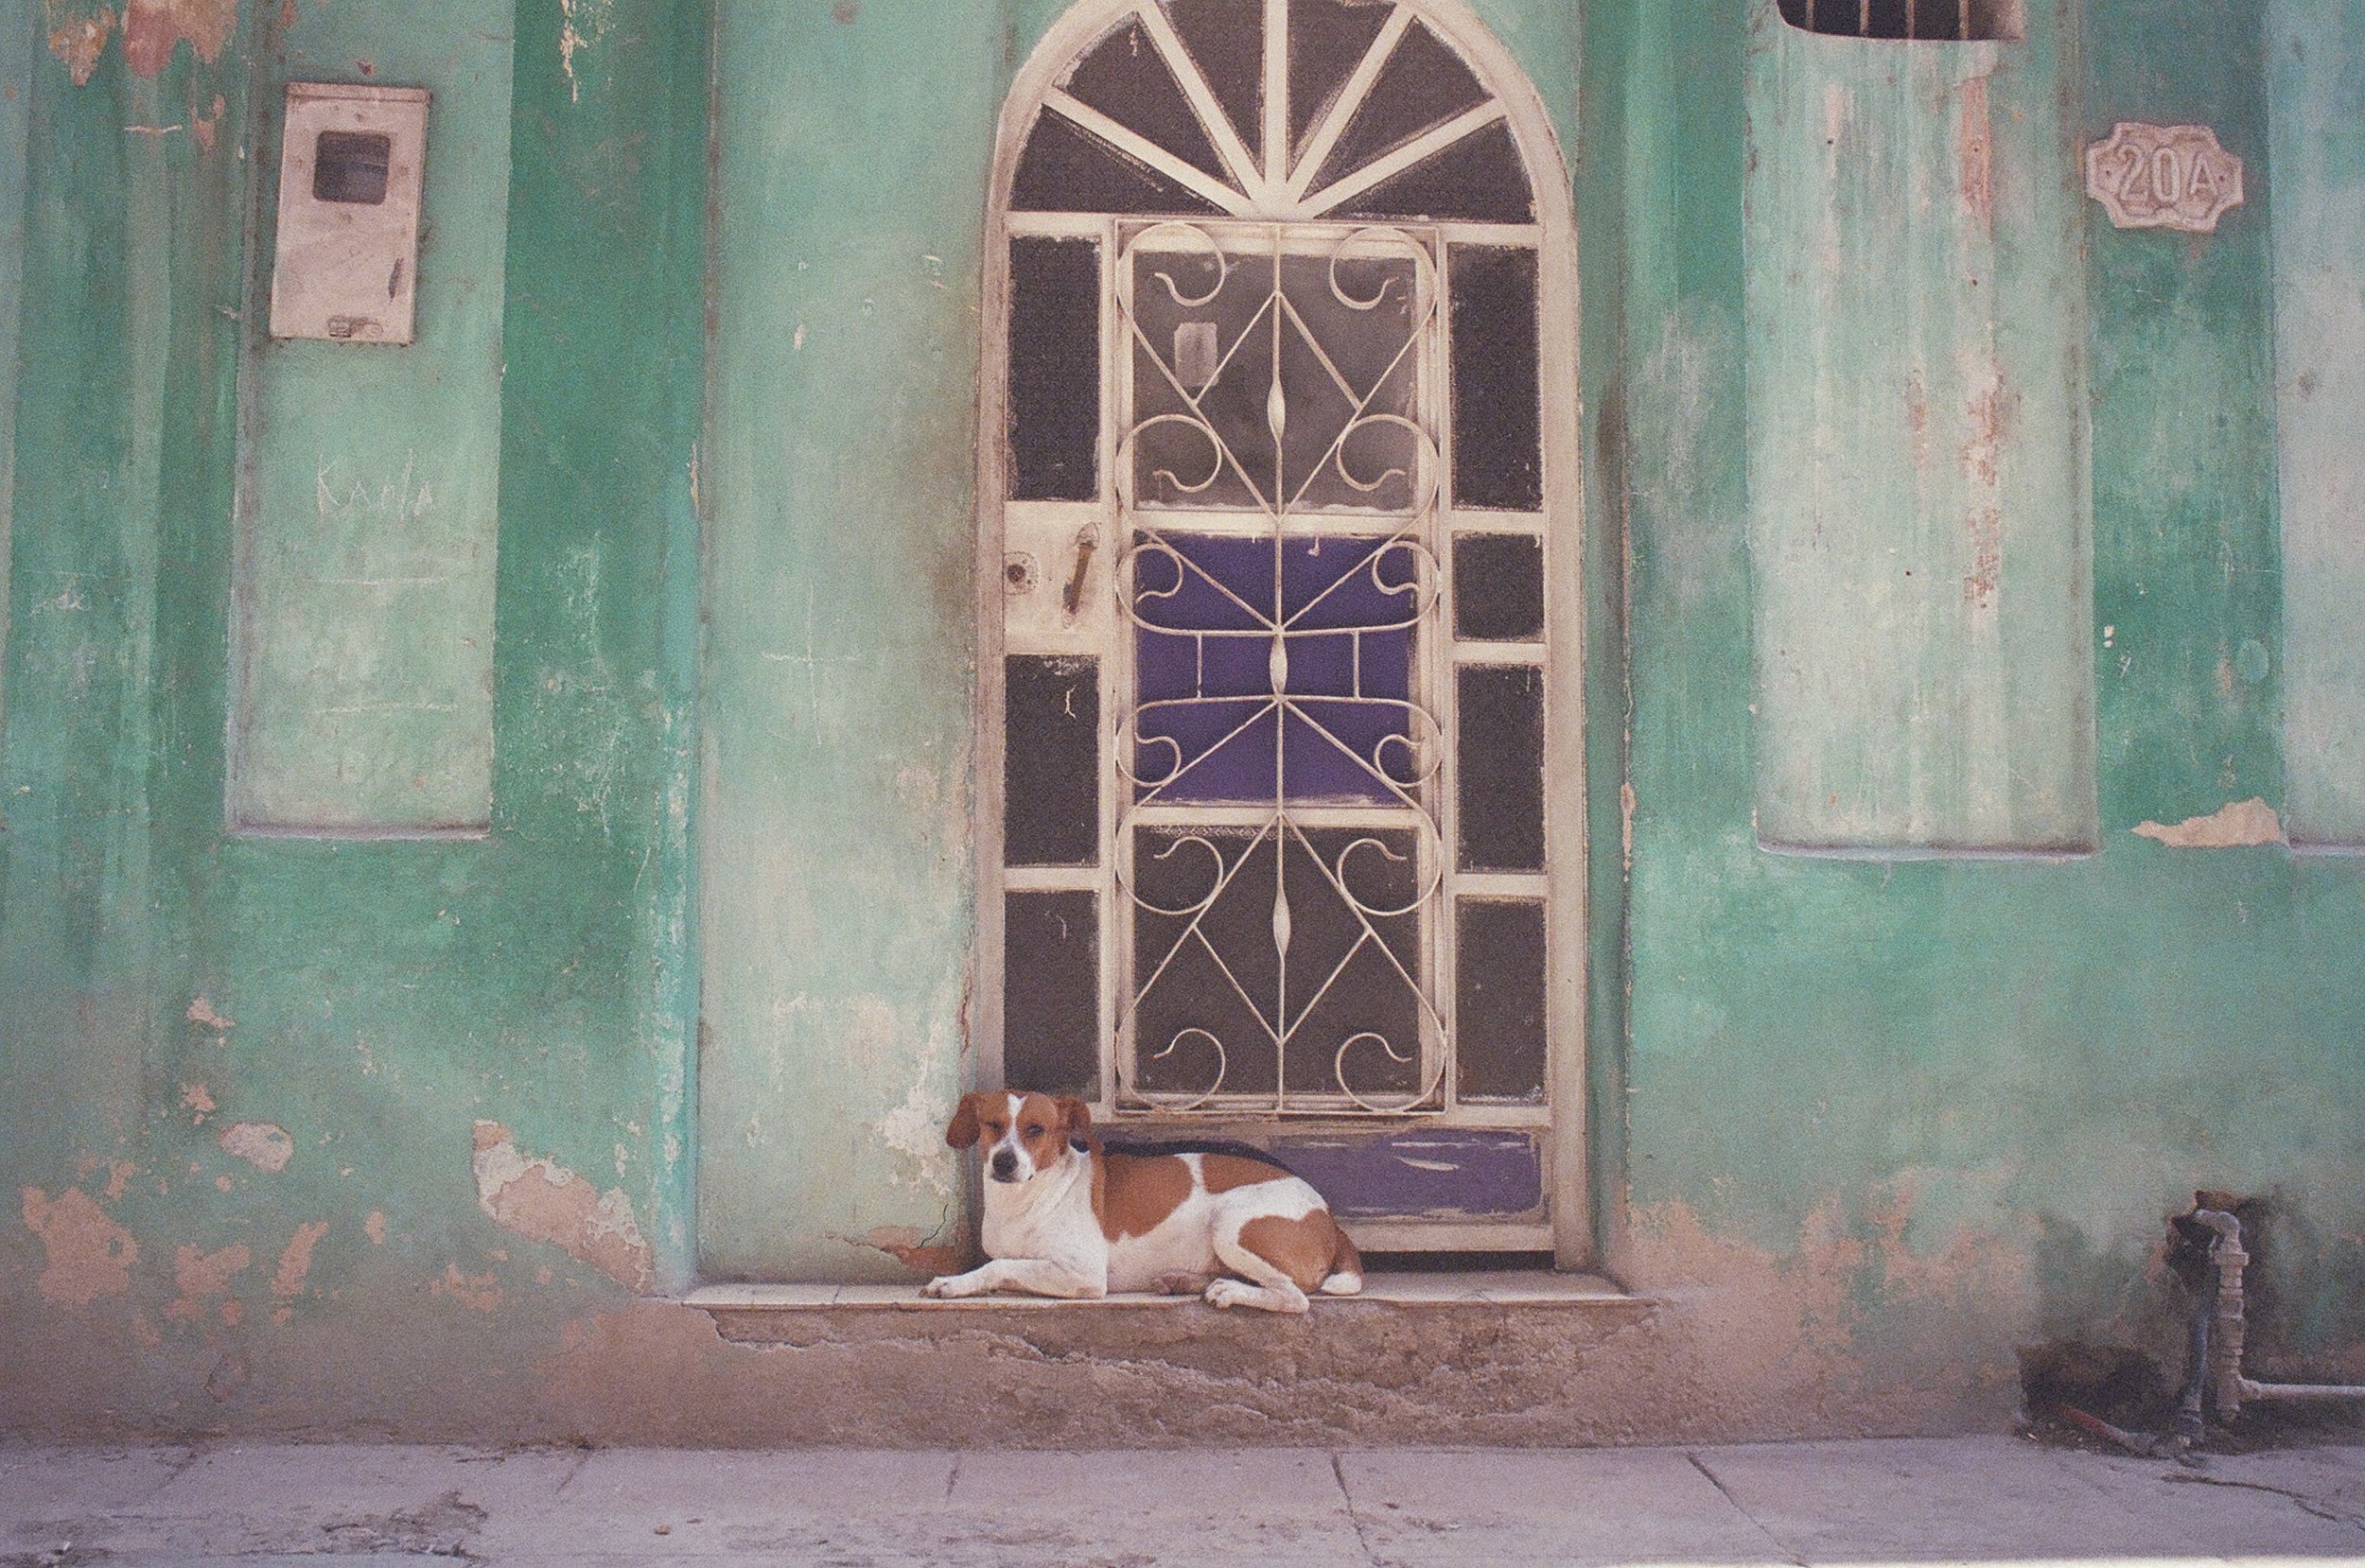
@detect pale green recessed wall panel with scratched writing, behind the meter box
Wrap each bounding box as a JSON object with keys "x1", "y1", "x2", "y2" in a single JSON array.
[{"x1": 230, "y1": 0, "x2": 516, "y2": 832}]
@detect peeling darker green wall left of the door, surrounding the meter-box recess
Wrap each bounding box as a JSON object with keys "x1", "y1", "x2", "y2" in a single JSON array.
[{"x1": 0, "y1": 0, "x2": 705, "y2": 1431}]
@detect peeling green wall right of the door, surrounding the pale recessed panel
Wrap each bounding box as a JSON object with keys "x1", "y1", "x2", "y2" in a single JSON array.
[{"x1": 1589, "y1": 0, "x2": 2365, "y2": 1414}]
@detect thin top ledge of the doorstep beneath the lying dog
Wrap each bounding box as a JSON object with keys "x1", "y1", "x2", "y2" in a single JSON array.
[{"x1": 681, "y1": 1270, "x2": 1658, "y2": 1338}]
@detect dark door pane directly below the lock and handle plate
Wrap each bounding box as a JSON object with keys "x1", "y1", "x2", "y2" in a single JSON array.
[{"x1": 1003, "y1": 653, "x2": 1100, "y2": 865}]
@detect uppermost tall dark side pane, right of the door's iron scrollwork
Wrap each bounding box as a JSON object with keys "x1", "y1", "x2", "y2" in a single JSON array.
[{"x1": 1452, "y1": 246, "x2": 1545, "y2": 511}]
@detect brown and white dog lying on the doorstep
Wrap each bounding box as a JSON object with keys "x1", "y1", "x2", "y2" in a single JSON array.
[{"x1": 922, "y1": 1092, "x2": 1362, "y2": 1313}]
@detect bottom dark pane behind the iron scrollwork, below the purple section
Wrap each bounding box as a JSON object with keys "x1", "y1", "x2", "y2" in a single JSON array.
[{"x1": 1133, "y1": 826, "x2": 1422, "y2": 1105}]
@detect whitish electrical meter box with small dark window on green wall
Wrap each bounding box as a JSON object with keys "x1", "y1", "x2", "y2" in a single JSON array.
[{"x1": 272, "y1": 83, "x2": 429, "y2": 343}]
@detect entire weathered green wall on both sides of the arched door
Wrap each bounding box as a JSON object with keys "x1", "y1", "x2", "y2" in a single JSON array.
[{"x1": 0, "y1": 0, "x2": 2365, "y2": 1436}]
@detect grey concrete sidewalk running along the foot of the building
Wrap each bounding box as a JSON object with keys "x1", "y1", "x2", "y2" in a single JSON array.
[{"x1": 0, "y1": 1433, "x2": 2365, "y2": 1568}]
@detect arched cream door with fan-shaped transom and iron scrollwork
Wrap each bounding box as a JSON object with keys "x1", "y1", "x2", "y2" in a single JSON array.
[{"x1": 989, "y1": 0, "x2": 1575, "y2": 1244}]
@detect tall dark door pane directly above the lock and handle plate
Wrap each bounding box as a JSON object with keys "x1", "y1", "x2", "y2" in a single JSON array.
[{"x1": 1007, "y1": 239, "x2": 1100, "y2": 501}]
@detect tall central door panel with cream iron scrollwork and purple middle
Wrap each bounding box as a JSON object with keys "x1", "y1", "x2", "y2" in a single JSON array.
[{"x1": 1114, "y1": 222, "x2": 1452, "y2": 1130}]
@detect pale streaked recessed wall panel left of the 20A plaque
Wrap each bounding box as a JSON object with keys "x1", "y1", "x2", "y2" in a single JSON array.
[{"x1": 1743, "y1": 0, "x2": 2095, "y2": 851}]
